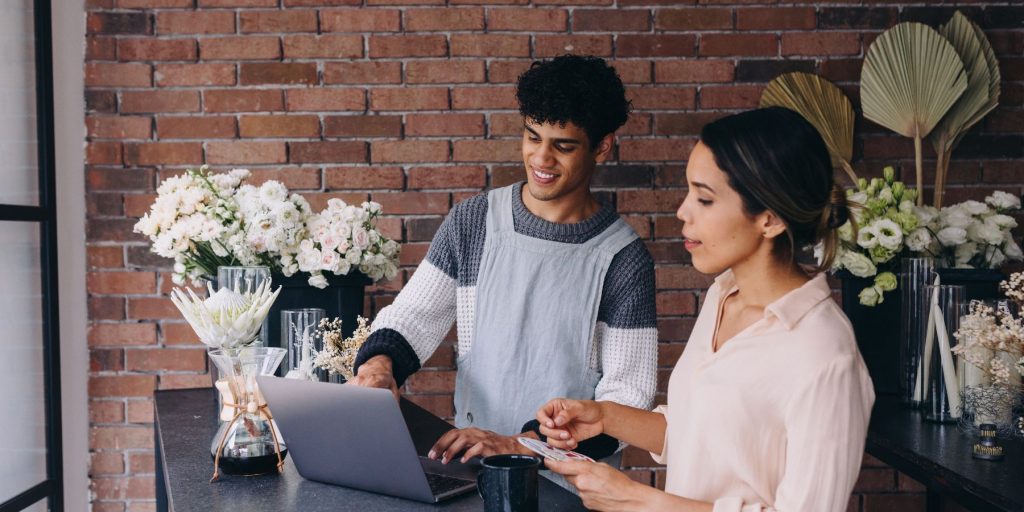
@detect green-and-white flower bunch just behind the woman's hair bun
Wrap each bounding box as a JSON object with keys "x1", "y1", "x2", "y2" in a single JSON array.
[{"x1": 819, "y1": 167, "x2": 922, "y2": 306}]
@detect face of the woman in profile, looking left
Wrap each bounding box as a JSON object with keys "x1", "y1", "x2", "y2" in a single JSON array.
[{"x1": 676, "y1": 142, "x2": 771, "y2": 274}]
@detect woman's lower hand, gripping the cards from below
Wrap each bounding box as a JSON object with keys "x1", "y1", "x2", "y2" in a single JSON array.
[{"x1": 544, "y1": 459, "x2": 652, "y2": 511}]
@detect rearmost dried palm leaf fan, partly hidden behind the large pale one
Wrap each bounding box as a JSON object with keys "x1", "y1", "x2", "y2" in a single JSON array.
[{"x1": 928, "y1": 11, "x2": 1000, "y2": 208}]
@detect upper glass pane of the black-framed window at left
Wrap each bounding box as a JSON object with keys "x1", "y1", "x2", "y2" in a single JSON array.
[{"x1": 0, "y1": 0, "x2": 39, "y2": 205}]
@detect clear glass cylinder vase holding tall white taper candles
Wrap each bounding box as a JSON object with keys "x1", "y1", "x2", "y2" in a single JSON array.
[{"x1": 921, "y1": 285, "x2": 965, "y2": 423}]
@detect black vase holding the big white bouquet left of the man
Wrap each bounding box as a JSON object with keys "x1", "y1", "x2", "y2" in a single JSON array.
[{"x1": 264, "y1": 271, "x2": 373, "y2": 356}]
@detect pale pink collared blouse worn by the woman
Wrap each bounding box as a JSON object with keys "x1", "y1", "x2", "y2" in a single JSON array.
[{"x1": 652, "y1": 270, "x2": 876, "y2": 512}]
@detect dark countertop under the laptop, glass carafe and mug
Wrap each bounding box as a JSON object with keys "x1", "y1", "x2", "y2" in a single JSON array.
[{"x1": 155, "y1": 388, "x2": 585, "y2": 512}]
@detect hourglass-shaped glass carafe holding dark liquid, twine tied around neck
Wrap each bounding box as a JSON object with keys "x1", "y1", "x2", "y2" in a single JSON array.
[{"x1": 210, "y1": 347, "x2": 288, "y2": 481}]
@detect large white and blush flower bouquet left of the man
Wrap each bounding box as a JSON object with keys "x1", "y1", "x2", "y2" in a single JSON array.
[{"x1": 135, "y1": 166, "x2": 400, "y2": 288}]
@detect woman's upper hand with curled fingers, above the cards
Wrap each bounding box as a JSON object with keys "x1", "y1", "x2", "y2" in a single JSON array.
[{"x1": 537, "y1": 398, "x2": 604, "y2": 450}]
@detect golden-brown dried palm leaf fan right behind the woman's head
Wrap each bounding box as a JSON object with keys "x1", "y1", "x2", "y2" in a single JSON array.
[{"x1": 761, "y1": 72, "x2": 857, "y2": 183}]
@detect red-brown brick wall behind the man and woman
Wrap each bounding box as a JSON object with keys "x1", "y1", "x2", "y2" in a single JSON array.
[{"x1": 83, "y1": 0, "x2": 1024, "y2": 512}]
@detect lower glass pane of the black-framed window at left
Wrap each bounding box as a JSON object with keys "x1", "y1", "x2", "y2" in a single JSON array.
[{"x1": 0, "y1": 221, "x2": 46, "y2": 503}]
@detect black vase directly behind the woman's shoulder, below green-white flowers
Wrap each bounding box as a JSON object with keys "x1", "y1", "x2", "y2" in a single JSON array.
[{"x1": 837, "y1": 270, "x2": 901, "y2": 394}]
